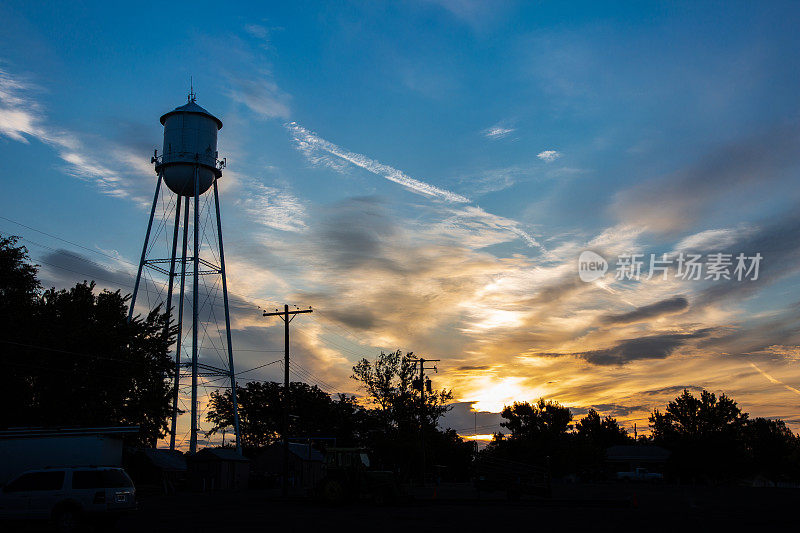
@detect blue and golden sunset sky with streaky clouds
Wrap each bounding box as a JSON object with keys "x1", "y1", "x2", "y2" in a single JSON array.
[{"x1": 0, "y1": 0, "x2": 800, "y2": 444}]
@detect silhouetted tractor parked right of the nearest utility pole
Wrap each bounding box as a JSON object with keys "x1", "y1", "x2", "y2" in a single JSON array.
[{"x1": 317, "y1": 448, "x2": 400, "y2": 504}]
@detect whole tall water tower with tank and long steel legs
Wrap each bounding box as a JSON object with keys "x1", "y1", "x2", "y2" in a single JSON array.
[{"x1": 128, "y1": 91, "x2": 241, "y2": 453}]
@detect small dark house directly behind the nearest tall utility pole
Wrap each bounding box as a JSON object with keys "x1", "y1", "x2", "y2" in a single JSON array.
[{"x1": 253, "y1": 442, "x2": 325, "y2": 489}]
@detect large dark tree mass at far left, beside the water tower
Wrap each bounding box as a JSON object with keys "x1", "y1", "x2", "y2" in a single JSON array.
[{"x1": 0, "y1": 234, "x2": 175, "y2": 445}]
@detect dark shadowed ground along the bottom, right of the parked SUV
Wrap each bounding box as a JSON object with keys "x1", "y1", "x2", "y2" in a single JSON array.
[{"x1": 108, "y1": 484, "x2": 800, "y2": 533}]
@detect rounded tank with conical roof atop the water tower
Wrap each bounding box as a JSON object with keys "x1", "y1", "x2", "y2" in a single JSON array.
[{"x1": 156, "y1": 97, "x2": 222, "y2": 196}]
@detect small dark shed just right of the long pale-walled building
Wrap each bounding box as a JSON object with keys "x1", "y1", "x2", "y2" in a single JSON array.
[{"x1": 125, "y1": 448, "x2": 188, "y2": 494}]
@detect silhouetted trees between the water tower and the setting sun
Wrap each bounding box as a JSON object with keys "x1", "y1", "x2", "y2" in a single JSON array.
[{"x1": 206, "y1": 351, "x2": 473, "y2": 480}]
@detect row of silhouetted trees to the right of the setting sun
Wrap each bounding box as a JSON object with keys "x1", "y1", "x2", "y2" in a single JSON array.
[{"x1": 481, "y1": 390, "x2": 800, "y2": 483}]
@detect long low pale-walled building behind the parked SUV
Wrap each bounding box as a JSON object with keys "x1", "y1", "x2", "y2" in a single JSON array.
[{"x1": 0, "y1": 426, "x2": 139, "y2": 484}]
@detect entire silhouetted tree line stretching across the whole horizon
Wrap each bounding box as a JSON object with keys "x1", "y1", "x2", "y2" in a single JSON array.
[{"x1": 0, "y1": 236, "x2": 800, "y2": 482}]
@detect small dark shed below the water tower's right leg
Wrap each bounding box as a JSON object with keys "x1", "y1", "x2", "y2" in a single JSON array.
[{"x1": 187, "y1": 448, "x2": 250, "y2": 492}]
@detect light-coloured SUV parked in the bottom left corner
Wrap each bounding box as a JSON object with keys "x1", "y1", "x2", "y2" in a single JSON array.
[{"x1": 0, "y1": 466, "x2": 136, "y2": 531}]
